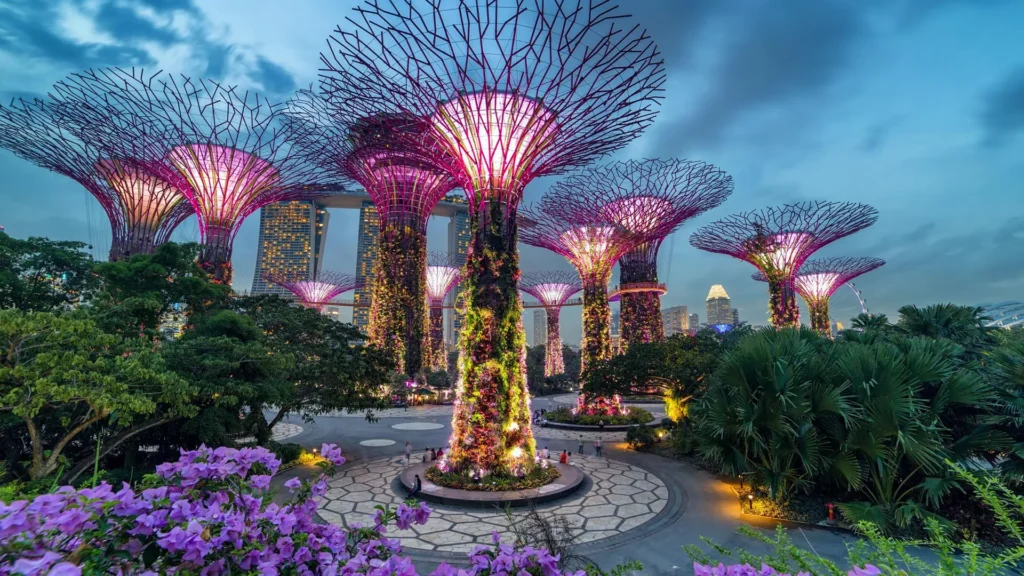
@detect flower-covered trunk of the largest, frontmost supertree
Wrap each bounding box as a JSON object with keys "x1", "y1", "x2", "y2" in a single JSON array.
[{"x1": 442, "y1": 201, "x2": 535, "y2": 474}]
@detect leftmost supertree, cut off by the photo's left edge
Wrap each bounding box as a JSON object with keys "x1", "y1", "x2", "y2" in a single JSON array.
[{"x1": 0, "y1": 99, "x2": 193, "y2": 260}]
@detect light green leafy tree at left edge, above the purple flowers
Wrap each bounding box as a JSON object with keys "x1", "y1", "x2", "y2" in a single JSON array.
[{"x1": 0, "y1": 311, "x2": 195, "y2": 480}]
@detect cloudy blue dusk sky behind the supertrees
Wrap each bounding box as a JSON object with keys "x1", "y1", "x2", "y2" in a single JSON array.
[{"x1": 0, "y1": 0, "x2": 1024, "y2": 342}]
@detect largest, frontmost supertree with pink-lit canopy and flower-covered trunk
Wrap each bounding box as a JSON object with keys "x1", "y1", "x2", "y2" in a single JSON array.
[{"x1": 322, "y1": 0, "x2": 665, "y2": 474}]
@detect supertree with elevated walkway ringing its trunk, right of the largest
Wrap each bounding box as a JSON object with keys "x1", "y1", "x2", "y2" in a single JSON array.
[{"x1": 551, "y1": 159, "x2": 732, "y2": 346}]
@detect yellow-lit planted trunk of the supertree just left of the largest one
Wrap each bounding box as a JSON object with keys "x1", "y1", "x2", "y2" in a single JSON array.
[{"x1": 367, "y1": 227, "x2": 428, "y2": 376}]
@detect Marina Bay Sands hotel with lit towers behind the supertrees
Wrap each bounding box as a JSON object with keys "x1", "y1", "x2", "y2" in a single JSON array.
[{"x1": 252, "y1": 191, "x2": 469, "y2": 344}]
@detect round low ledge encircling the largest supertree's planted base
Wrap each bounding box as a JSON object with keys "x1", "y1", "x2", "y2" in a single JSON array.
[{"x1": 395, "y1": 462, "x2": 587, "y2": 508}]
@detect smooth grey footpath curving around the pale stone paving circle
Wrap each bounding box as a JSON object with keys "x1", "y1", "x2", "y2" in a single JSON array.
[{"x1": 275, "y1": 397, "x2": 854, "y2": 576}]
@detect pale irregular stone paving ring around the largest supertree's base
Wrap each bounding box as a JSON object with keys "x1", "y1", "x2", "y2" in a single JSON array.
[{"x1": 318, "y1": 456, "x2": 669, "y2": 552}]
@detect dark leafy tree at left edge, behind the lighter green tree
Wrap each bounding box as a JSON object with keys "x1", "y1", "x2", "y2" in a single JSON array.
[{"x1": 0, "y1": 232, "x2": 97, "y2": 312}]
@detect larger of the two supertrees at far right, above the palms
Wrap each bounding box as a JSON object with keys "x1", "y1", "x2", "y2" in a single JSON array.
[{"x1": 690, "y1": 201, "x2": 879, "y2": 326}]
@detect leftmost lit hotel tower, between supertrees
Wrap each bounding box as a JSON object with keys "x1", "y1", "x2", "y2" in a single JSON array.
[{"x1": 252, "y1": 200, "x2": 331, "y2": 299}]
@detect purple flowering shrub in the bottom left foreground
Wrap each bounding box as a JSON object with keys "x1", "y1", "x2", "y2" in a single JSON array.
[{"x1": 0, "y1": 444, "x2": 598, "y2": 576}]
